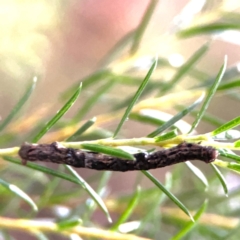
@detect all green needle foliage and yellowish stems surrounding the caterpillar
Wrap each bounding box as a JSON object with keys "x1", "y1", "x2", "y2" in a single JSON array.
[{"x1": 0, "y1": 0, "x2": 240, "y2": 239}]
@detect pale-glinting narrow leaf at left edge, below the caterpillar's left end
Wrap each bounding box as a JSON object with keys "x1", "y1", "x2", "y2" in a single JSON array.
[{"x1": 0, "y1": 179, "x2": 38, "y2": 212}]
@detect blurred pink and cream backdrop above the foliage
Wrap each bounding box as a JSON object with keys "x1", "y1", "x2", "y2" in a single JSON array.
[{"x1": 0, "y1": 0, "x2": 240, "y2": 109}]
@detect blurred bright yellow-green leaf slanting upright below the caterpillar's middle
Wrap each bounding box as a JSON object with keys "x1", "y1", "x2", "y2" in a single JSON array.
[{"x1": 111, "y1": 187, "x2": 140, "y2": 231}]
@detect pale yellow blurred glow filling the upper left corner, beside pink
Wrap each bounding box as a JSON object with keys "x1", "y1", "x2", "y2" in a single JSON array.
[{"x1": 0, "y1": 0, "x2": 59, "y2": 79}]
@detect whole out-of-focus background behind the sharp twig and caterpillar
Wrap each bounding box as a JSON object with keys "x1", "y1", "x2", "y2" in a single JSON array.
[{"x1": 0, "y1": 0, "x2": 240, "y2": 240}]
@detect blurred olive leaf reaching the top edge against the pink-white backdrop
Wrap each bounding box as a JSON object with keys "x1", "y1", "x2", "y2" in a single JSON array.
[{"x1": 130, "y1": 0, "x2": 159, "y2": 54}]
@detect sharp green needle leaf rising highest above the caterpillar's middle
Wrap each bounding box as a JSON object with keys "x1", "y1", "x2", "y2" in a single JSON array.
[{"x1": 113, "y1": 60, "x2": 157, "y2": 138}]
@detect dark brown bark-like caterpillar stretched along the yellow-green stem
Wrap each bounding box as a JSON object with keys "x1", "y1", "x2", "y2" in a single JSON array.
[{"x1": 19, "y1": 142, "x2": 218, "y2": 172}]
